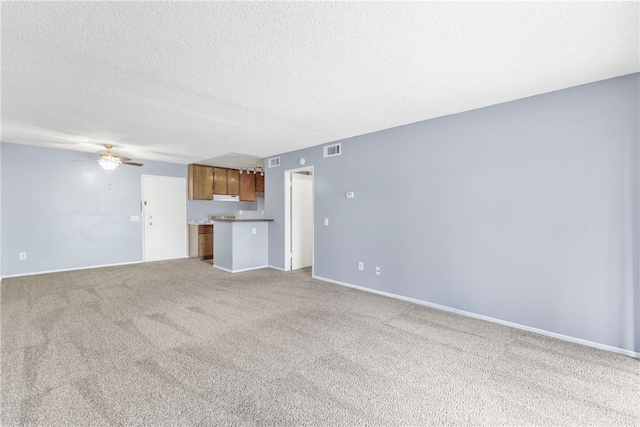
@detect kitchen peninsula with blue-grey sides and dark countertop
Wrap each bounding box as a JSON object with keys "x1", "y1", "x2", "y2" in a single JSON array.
[{"x1": 213, "y1": 217, "x2": 273, "y2": 273}]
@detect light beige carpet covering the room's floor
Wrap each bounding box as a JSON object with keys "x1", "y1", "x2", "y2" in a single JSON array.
[{"x1": 0, "y1": 259, "x2": 640, "y2": 426}]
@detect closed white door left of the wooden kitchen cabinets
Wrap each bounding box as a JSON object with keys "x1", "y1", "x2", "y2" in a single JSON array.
[{"x1": 142, "y1": 175, "x2": 187, "y2": 262}]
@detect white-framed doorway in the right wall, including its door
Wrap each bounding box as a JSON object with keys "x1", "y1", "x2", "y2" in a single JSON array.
[{"x1": 284, "y1": 166, "x2": 314, "y2": 271}]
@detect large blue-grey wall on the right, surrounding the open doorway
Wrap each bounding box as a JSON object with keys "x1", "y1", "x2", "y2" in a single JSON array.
[{"x1": 265, "y1": 74, "x2": 640, "y2": 352}]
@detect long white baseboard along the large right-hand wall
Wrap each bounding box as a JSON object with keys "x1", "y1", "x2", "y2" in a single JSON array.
[{"x1": 313, "y1": 276, "x2": 640, "y2": 359}]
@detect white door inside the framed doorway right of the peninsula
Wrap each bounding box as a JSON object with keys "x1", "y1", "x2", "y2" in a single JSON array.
[{"x1": 291, "y1": 173, "x2": 313, "y2": 270}]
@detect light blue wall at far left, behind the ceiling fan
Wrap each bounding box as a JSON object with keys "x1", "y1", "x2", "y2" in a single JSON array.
[{"x1": 0, "y1": 143, "x2": 187, "y2": 277}]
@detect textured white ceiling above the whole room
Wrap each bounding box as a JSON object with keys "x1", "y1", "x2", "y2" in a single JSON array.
[{"x1": 1, "y1": 1, "x2": 640, "y2": 163}]
